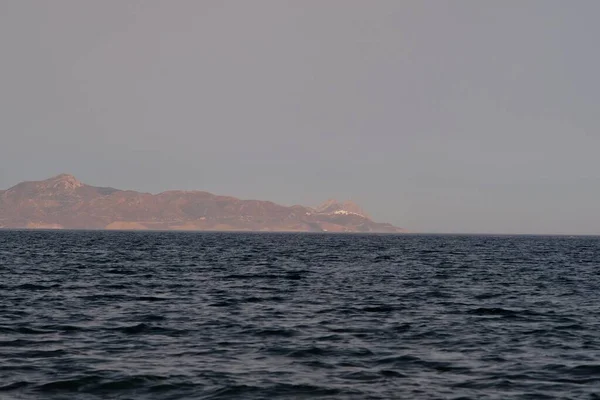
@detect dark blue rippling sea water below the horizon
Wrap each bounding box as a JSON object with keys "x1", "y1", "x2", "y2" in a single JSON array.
[{"x1": 0, "y1": 231, "x2": 600, "y2": 400}]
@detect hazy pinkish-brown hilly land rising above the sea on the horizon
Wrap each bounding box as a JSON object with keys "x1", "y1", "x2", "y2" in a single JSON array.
[{"x1": 0, "y1": 174, "x2": 403, "y2": 233}]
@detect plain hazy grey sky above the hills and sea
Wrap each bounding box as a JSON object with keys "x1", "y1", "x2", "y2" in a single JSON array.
[{"x1": 0, "y1": 0, "x2": 600, "y2": 234}]
